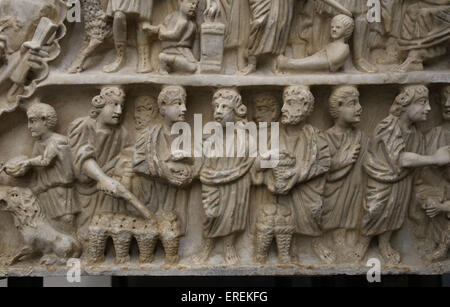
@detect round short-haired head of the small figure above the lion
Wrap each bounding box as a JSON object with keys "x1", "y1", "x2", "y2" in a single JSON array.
[{"x1": 27, "y1": 102, "x2": 58, "y2": 139}]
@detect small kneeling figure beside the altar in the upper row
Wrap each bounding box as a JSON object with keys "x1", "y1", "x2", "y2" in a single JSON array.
[{"x1": 143, "y1": 0, "x2": 198, "y2": 74}]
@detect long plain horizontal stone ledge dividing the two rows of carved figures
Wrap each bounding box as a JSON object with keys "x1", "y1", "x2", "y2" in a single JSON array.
[{"x1": 39, "y1": 71, "x2": 450, "y2": 88}]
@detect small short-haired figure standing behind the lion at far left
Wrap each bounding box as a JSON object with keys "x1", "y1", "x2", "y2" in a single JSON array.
[{"x1": 5, "y1": 103, "x2": 78, "y2": 232}]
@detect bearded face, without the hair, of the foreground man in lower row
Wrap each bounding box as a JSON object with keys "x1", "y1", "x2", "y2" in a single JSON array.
[{"x1": 281, "y1": 95, "x2": 311, "y2": 125}]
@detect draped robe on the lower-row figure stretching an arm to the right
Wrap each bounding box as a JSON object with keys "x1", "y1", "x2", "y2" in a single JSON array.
[{"x1": 363, "y1": 115, "x2": 424, "y2": 236}]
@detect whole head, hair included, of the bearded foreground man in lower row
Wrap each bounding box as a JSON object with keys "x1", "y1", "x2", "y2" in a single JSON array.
[{"x1": 281, "y1": 85, "x2": 314, "y2": 125}]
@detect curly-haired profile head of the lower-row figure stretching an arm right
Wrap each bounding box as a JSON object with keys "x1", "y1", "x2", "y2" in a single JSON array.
[{"x1": 390, "y1": 85, "x2": 431, "y2": 122}]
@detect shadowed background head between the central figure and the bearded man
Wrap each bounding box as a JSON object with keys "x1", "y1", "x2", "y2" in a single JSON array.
[{"x1": 253, "y1": 93, "x2": 281, "y2": 124}]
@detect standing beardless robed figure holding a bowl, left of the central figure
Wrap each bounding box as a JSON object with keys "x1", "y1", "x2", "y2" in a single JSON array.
[{"x1": 133, "y1": 86, "x2": 194, "y2": 264}]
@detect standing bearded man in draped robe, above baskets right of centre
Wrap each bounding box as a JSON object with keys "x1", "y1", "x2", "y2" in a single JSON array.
[{"x1": 264, "y1": 85, "x2": 334, "y2": 263}]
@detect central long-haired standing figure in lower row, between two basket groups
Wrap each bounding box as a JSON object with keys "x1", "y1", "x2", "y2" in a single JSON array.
[{"x1": 194, "y1": 89, "x2": 255, "y2": 265}]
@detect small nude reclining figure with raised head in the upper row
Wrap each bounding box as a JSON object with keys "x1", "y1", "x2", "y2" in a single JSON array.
[{"x1": 278, "y1": 15, "x2": 355, "y2": 72}]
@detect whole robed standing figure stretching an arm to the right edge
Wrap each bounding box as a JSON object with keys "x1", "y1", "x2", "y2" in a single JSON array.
[{"x1": 357, "y1": 85, "x2": 450, "y2": 264}]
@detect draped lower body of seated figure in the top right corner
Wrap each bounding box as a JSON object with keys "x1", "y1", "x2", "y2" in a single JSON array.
[{"x1": 394, "y1": 0, "x2": 450, "y2": 72}]
